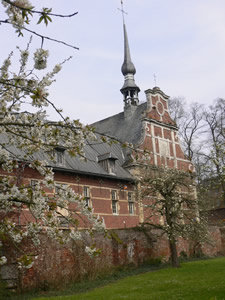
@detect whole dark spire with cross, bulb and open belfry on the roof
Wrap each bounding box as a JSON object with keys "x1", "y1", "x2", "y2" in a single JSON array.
[{"x1": 120, "y1": 0, "x2": 140, "y2": 108}]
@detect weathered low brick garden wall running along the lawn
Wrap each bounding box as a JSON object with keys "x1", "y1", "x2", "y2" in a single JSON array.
[{"x1": 1, "y1": 226, "x2": 225, "y2": 289}]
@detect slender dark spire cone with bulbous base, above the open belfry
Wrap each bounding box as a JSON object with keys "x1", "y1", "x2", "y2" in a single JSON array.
[{"x1": 121, "y1": 23, "x2": 136, "y2": 76}]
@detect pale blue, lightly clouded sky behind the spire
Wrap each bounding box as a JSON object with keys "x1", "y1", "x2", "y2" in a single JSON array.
[{"x1": 0, "y1": 0, "x2": 225, "y2": 124}]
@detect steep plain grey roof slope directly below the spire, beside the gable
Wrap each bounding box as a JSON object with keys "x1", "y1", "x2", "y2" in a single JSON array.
[{"x1": 92, "y1": 102, "x2": 147, "y2": 145}]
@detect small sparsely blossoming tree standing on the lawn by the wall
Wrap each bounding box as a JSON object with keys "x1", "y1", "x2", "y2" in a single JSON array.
[{"x1": 141, "y1": 165, "x2": 207, "y2": 267}]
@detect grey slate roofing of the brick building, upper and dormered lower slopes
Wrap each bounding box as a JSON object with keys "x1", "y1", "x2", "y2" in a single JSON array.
[{"x1": 0, "y1": 103, "x2": 147, "y2": 181}]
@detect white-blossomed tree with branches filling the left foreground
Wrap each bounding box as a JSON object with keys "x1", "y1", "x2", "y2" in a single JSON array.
[{"x1": 0, "y1": 0, "x2": 104, "y2": 268}]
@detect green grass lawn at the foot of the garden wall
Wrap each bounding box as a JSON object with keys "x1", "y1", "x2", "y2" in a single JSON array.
[{"x1": 35, "y1": 258, "x2": 225, "y2": 300}]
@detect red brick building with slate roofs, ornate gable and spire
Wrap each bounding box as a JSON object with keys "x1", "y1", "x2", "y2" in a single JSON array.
[{"x1": 0, "y1": 19, "x2": 193, "y2": 228}]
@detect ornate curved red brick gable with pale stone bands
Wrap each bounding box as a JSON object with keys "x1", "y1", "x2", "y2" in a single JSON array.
[{"x1": 140, "y1": 88, "x2": 190, "y2": 171}]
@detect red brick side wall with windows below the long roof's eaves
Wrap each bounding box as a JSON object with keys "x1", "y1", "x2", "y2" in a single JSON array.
[{"x1": 0, "y1": 168, "x2": 139, "y2": 228}]
